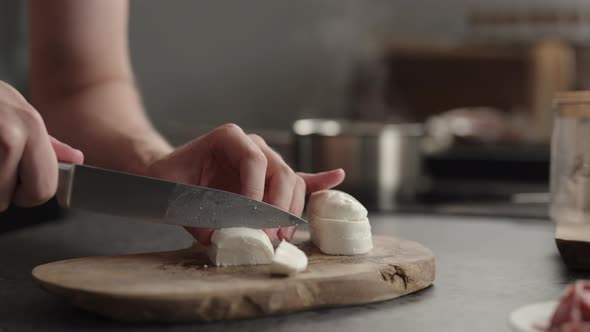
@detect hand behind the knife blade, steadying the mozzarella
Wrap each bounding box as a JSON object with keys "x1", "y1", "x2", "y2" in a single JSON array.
[{"x1": 147, "y1": 124, "x2": 344, "y2": 244}]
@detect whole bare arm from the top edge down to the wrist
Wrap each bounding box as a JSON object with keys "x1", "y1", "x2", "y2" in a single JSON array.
[{"x1": 28, "y1": 0, "x2": 172, "y2": 173}]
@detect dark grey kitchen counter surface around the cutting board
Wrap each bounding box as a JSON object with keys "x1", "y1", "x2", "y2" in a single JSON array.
[{"x1": 0, "y1": 213, "x2": 590, "y2": 332}]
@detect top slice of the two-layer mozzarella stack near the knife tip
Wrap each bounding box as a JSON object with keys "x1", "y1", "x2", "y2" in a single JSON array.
[{"x1": 307, "y1": 190, "x2": 367, "y2": 220}]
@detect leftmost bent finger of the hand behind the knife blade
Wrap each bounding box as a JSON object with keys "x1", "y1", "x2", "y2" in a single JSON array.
[{"x1": 207, "y1": 124, "x2": 267, "y2": 201}]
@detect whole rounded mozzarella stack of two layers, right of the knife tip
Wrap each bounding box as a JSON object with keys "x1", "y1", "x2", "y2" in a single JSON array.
[{"x1": 308, "y1": 190, "x2": 373, "y2": 255}]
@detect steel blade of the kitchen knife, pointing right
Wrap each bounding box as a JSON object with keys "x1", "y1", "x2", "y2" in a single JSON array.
[{"x1": 56, "y1": 163, "x2": 306, "y2": 229}]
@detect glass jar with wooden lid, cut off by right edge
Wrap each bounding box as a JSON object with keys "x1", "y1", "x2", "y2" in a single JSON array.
[{"x1": 549, "y1": 91, "x2": 590, "y2": 224}]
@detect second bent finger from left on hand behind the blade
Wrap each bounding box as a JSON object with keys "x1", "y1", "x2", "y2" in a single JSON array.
[{"x1": 248, "y1": 134, "x2": 298, "y2": 211}]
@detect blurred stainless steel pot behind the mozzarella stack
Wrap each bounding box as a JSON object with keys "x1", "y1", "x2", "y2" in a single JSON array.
[{"x1": 293, "y1": 119, "x2": 423, "y2": 211}]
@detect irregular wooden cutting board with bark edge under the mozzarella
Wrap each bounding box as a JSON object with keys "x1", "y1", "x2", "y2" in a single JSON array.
[{"x1": 33, "y1": 232, "x2": 435, "y2": 321}]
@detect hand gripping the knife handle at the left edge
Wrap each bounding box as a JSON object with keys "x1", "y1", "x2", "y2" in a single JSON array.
[{"x1": 0, "y1": 81, "x2": 84, "y2": 212}]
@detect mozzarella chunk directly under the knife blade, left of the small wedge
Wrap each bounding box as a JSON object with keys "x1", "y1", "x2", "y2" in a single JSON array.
[{"x1": 207, "y1": 227, "x2": 274, "y2": 266}]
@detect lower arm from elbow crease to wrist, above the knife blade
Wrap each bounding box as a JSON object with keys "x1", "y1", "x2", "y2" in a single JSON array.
[{"x1": 32, "y1": 78, "x2": 172, "y2": 174}]
